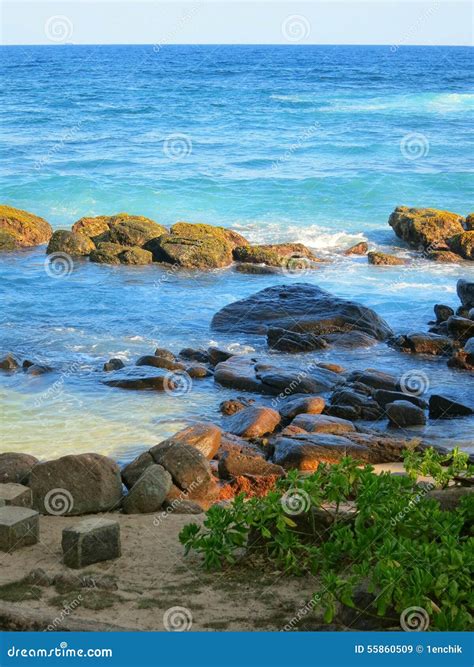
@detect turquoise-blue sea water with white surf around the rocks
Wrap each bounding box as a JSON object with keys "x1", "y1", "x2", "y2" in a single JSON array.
[{"x1": 0, "y1": 46, "x2": 474, "y2": 458}]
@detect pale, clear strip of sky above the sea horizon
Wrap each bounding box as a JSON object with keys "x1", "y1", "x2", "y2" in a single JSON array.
[{"x1": 1, "y1": 0, "x2": 473, "y2": 46}]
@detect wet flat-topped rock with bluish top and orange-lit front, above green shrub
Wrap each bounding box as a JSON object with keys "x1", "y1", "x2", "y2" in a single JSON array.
[{"x1": 273, "y1": 434, "x2": 369, "y2": 472}]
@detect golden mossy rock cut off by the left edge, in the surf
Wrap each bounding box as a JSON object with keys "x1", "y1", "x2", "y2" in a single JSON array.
[{"x1": 0, "y1": 205, "x2": 53, "y2": 250}]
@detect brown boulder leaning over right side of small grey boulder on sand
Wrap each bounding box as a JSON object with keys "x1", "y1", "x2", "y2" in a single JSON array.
[{"x1": 150, "y1": 440, "x2": 215, "y2": 499}]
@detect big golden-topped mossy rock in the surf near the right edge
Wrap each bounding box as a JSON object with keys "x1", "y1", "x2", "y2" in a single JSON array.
[{"x1": 388, "y1": 206, "x2": 464, "y2": 250}]
